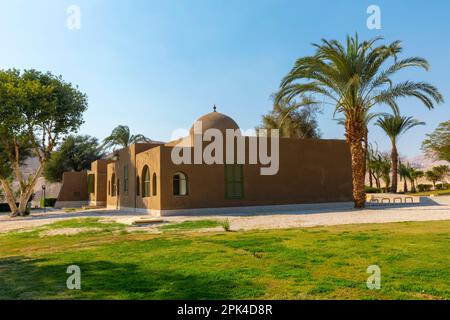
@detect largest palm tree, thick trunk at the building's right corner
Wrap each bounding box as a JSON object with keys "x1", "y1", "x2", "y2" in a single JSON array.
[{"x1": 277, "y1": 35, "x2": 444, "y2": 208}]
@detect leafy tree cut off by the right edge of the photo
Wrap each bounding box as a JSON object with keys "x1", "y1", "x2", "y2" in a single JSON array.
[{"x1": 422, "y1": 120, "x2": 450, "y2": 162}]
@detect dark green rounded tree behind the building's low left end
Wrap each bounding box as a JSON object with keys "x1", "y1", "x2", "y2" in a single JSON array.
[{"x1": 44, "y1": 135, "x2": 104, "y2": 182}]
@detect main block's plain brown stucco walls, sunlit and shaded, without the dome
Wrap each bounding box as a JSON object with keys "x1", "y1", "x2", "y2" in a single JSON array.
[{"x1": 100, "y1": 139, "x2": 351, "y2": 211}]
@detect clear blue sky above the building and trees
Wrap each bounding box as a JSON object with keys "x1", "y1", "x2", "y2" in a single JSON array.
[{"x1": 0, "y1": 0, "x2": 450, "y2": 156}]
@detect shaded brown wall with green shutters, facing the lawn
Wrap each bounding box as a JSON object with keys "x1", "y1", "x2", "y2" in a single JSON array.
[{"x1": 160, "y1": 139, "x2": 352, "y2": 210}]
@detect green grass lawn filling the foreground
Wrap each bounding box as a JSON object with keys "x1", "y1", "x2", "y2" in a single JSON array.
[{"x1": 0, "y1": 219, "x2": 450, "y2": 299}]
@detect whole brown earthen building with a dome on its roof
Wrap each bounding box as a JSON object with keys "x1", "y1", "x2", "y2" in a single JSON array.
[{"x1": 55, "y1": 112, "x2": 352, "y2": 216}]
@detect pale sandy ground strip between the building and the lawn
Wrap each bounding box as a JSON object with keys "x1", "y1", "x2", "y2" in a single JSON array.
[{"x1": 0, "y1": 197, "x2": 450, "y2": 233}]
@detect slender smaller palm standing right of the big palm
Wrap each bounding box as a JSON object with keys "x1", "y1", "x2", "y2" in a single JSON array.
[{"x1": 375, "y1": 112, "x2": 425, "y2": 193}]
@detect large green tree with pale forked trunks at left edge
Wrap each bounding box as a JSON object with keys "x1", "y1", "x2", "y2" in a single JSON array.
[{"x1": 0, "y1": 70, "x2": 87, "y2": 216}]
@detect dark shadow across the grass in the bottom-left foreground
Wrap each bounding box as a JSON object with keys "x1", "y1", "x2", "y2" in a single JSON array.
[{"x1": 0, "y1": 257, "x2": 264, "y2": 300}]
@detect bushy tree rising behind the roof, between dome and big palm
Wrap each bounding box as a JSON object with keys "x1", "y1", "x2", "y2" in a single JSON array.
[{"x1": 256, "y1": 99, "x2": 320, "y2": 139}]
